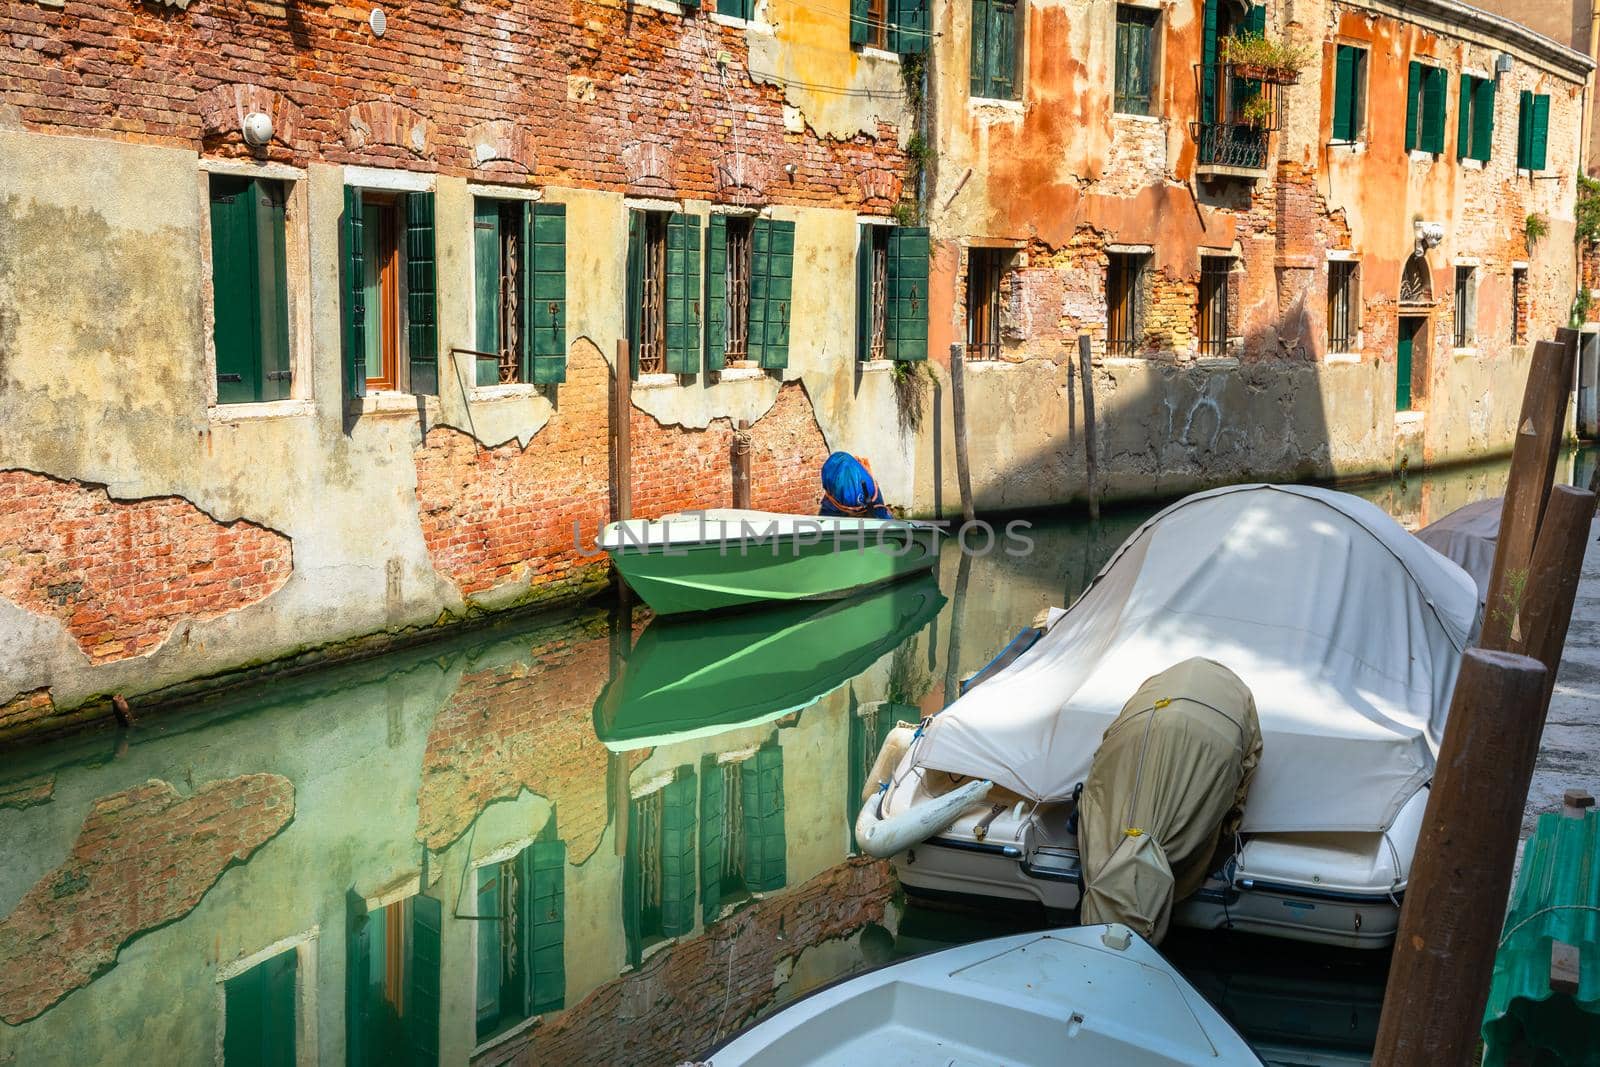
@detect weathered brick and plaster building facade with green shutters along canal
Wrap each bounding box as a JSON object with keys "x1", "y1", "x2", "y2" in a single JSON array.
[{"x1": 0, "y1": 0, "x2": 1587, "y2": 726}]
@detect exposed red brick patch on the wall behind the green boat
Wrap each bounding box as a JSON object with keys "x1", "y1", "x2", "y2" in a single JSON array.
[{"x1": 414, "y1": 344, "x2": 827, "y2": 595}]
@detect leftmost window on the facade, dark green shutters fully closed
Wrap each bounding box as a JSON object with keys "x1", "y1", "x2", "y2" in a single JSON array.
[{"x1": 210, "y1": 174, "x2": 291, "y2": 403}]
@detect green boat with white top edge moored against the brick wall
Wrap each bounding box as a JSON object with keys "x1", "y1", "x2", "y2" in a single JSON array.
[{"x1": 600, "y1": 509, "x2": 939, "y2": 614}]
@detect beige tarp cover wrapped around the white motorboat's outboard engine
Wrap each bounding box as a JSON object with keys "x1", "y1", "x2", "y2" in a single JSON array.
[{"x1": 1078, "y1": 657, "x2": 1261, "y2": 942}]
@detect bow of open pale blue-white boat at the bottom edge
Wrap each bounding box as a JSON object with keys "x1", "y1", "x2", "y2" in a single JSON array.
[{"x1": 707, "y1": 925, "x2": 1261, "y2": 1067}]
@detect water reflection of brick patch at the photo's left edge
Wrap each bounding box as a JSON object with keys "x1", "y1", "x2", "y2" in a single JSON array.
[{"x1": 0, "y1": 774, "x2": 294, "y2": 1025}]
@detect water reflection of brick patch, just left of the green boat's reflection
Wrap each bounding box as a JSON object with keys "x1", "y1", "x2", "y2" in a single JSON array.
[{"x1": 416, "y1": 614, "x2": 648, "y2": 864}]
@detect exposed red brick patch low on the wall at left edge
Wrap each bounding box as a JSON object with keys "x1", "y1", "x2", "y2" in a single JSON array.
[{"x1": 0, "y1": 470, "x2": 293, "y2": 664}]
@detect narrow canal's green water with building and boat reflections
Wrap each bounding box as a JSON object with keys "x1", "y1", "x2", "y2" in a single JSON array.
[{"x1": 0, "y1": 454, "x2": 1592, "y2": 1065}]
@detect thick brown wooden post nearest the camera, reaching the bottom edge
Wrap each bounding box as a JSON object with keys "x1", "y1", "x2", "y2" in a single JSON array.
[{"x1": 1373, "y1": 648, "x2": 1546, "y2": 1067}]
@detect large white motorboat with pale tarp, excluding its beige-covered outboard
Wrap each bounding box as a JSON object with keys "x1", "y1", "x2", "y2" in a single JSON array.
[{"x1": 858, "y1": 485, "x2": 1478, "y2": 945}]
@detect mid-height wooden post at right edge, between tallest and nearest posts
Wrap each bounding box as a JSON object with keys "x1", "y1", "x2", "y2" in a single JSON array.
[{"x1": 1512, "y1": 485, "x2": 1595, "y2": 710}]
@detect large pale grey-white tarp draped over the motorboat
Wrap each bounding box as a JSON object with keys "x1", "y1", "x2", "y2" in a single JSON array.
[{"x1": 910, "y1": 485, "x2": 1478, "y2": 832}]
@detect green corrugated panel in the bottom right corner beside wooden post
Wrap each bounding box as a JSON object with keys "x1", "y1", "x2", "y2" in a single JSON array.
[{"x1": 1483, "y1": 811, "x2": 1600, "y2": 1067}]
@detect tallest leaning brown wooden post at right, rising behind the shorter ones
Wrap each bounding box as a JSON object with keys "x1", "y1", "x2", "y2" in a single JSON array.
[{"x1": 1478, "y1": 341, "x2": 1573, "y2": 649}]
